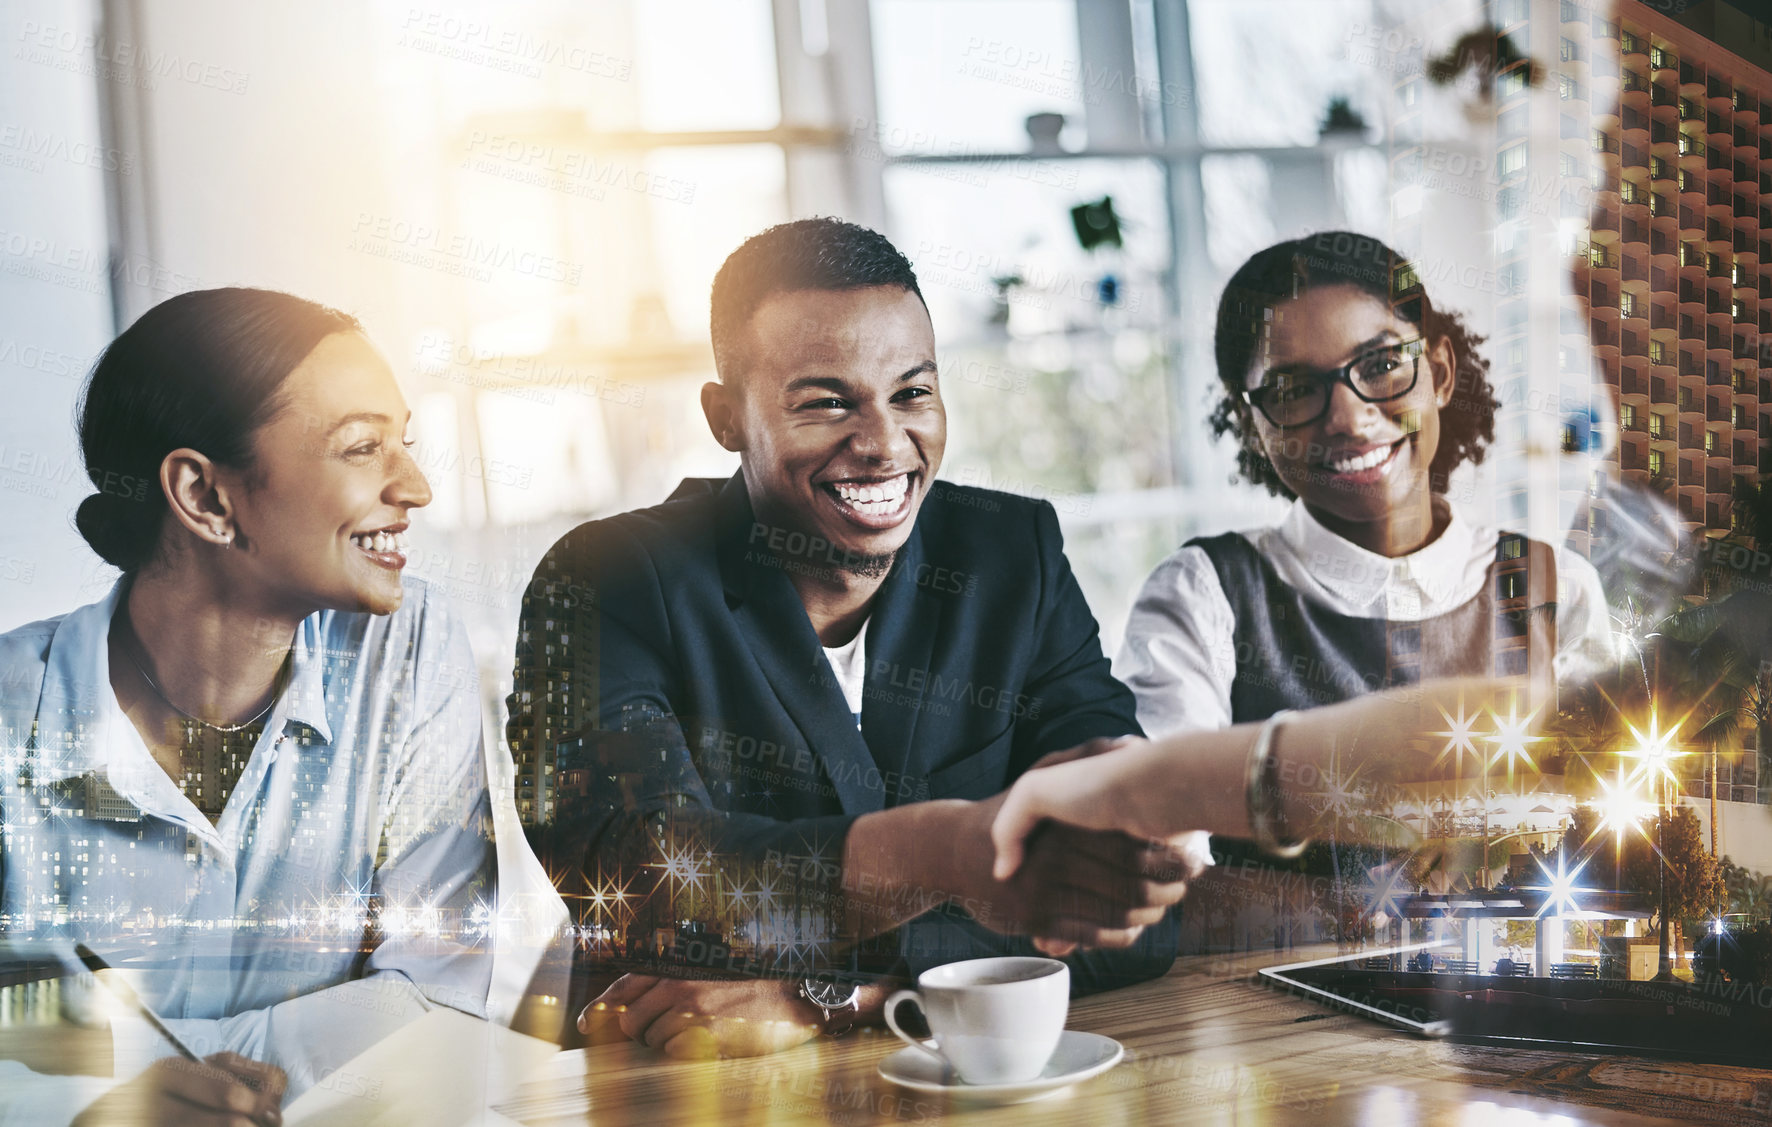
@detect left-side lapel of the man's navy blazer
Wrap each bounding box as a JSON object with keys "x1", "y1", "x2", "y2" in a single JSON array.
[{"x1": 718, "y1": 475, "x2": 886, "y2": 815}]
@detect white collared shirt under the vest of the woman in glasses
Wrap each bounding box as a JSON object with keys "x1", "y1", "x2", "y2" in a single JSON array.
[{"x1": 1115, "y1": 501, "x2": 1616, "y2": 737}]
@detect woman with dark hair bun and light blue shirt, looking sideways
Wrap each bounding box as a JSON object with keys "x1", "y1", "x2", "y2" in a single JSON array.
[{"x1": 0, "y1": 289, "x2": 496, "y2": 1122}]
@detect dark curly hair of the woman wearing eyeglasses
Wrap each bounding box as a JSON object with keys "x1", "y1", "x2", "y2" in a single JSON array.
[{"x1": 1210, "y1": 230, "x2": 1501, "y2": 498}]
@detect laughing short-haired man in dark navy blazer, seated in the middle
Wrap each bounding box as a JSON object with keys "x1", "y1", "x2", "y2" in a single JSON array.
[{"x1": 509, "y1": 220, "x2": 1187, "y2": 1054}]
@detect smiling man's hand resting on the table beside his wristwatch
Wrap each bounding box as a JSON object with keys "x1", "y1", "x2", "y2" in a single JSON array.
[{"x1": 578, "y1": 975, "x2": 822, "y2": 1060}]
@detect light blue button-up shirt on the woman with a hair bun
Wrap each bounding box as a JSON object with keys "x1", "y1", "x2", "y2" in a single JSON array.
[{"x1": 0, "y1": 579, "x2": 496, "y2": 1118}]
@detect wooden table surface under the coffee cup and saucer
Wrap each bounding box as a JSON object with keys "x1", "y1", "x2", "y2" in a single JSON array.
[{"x1": 500, "y1": 950, "x2": 1772, "y2": 1127}]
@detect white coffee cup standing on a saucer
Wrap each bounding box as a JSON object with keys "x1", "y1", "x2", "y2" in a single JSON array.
[{"x1": 886, "y1": 955, "x2": 1070, "y2": 1084}]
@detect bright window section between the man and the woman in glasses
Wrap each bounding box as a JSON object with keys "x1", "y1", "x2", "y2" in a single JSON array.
[{"x1": 870, "y1": 0, "x2": 1389, "y2": 645}]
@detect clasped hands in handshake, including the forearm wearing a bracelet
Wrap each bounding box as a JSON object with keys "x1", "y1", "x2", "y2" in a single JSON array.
[{"x1": 907, "y1": 679, "x2": 1554, "y2": 957}]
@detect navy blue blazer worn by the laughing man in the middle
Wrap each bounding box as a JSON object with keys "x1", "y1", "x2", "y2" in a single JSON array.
[{"x1": 507, "y1": 475, "x2": 1175, "y2": 992}]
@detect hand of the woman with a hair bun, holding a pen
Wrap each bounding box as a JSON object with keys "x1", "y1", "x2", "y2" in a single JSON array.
[{"x1": 74, "y1": 1053, "x2": 289, "y2": 1127}]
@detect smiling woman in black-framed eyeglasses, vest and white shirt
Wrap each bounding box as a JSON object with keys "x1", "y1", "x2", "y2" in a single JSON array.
[{"x1": 1115, "y1": 232, "x2": 1613, "y2": 737}]
